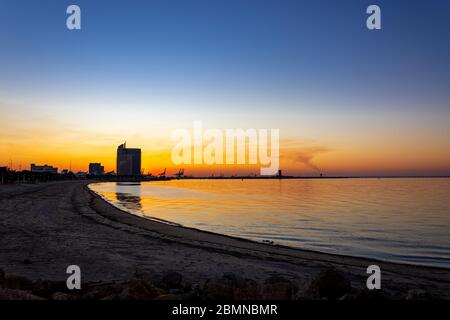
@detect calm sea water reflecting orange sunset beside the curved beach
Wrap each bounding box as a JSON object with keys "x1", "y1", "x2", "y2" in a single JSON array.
[{"x1": 90, "y1": 178, "x2": 450, "y2": 267}]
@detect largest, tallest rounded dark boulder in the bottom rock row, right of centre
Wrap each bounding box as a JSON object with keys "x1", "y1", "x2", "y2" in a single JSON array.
[{"x1": 301, "y1": 268, "x2": 352, "y2": 300}]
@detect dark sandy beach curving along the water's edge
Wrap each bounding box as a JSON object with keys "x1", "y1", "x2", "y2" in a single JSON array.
[{"x1": 0, "y1": 181, "x2": 450, "y2": 299}]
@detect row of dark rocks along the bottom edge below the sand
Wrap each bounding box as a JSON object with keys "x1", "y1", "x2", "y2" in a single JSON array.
[{"x1": 0, "y1": 269, "x2": 412, "y2": 301}]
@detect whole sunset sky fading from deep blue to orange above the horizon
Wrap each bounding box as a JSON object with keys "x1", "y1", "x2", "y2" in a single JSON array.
[{"x1": 0, "y1": 0, "x2": 450, "y2": 176}]
